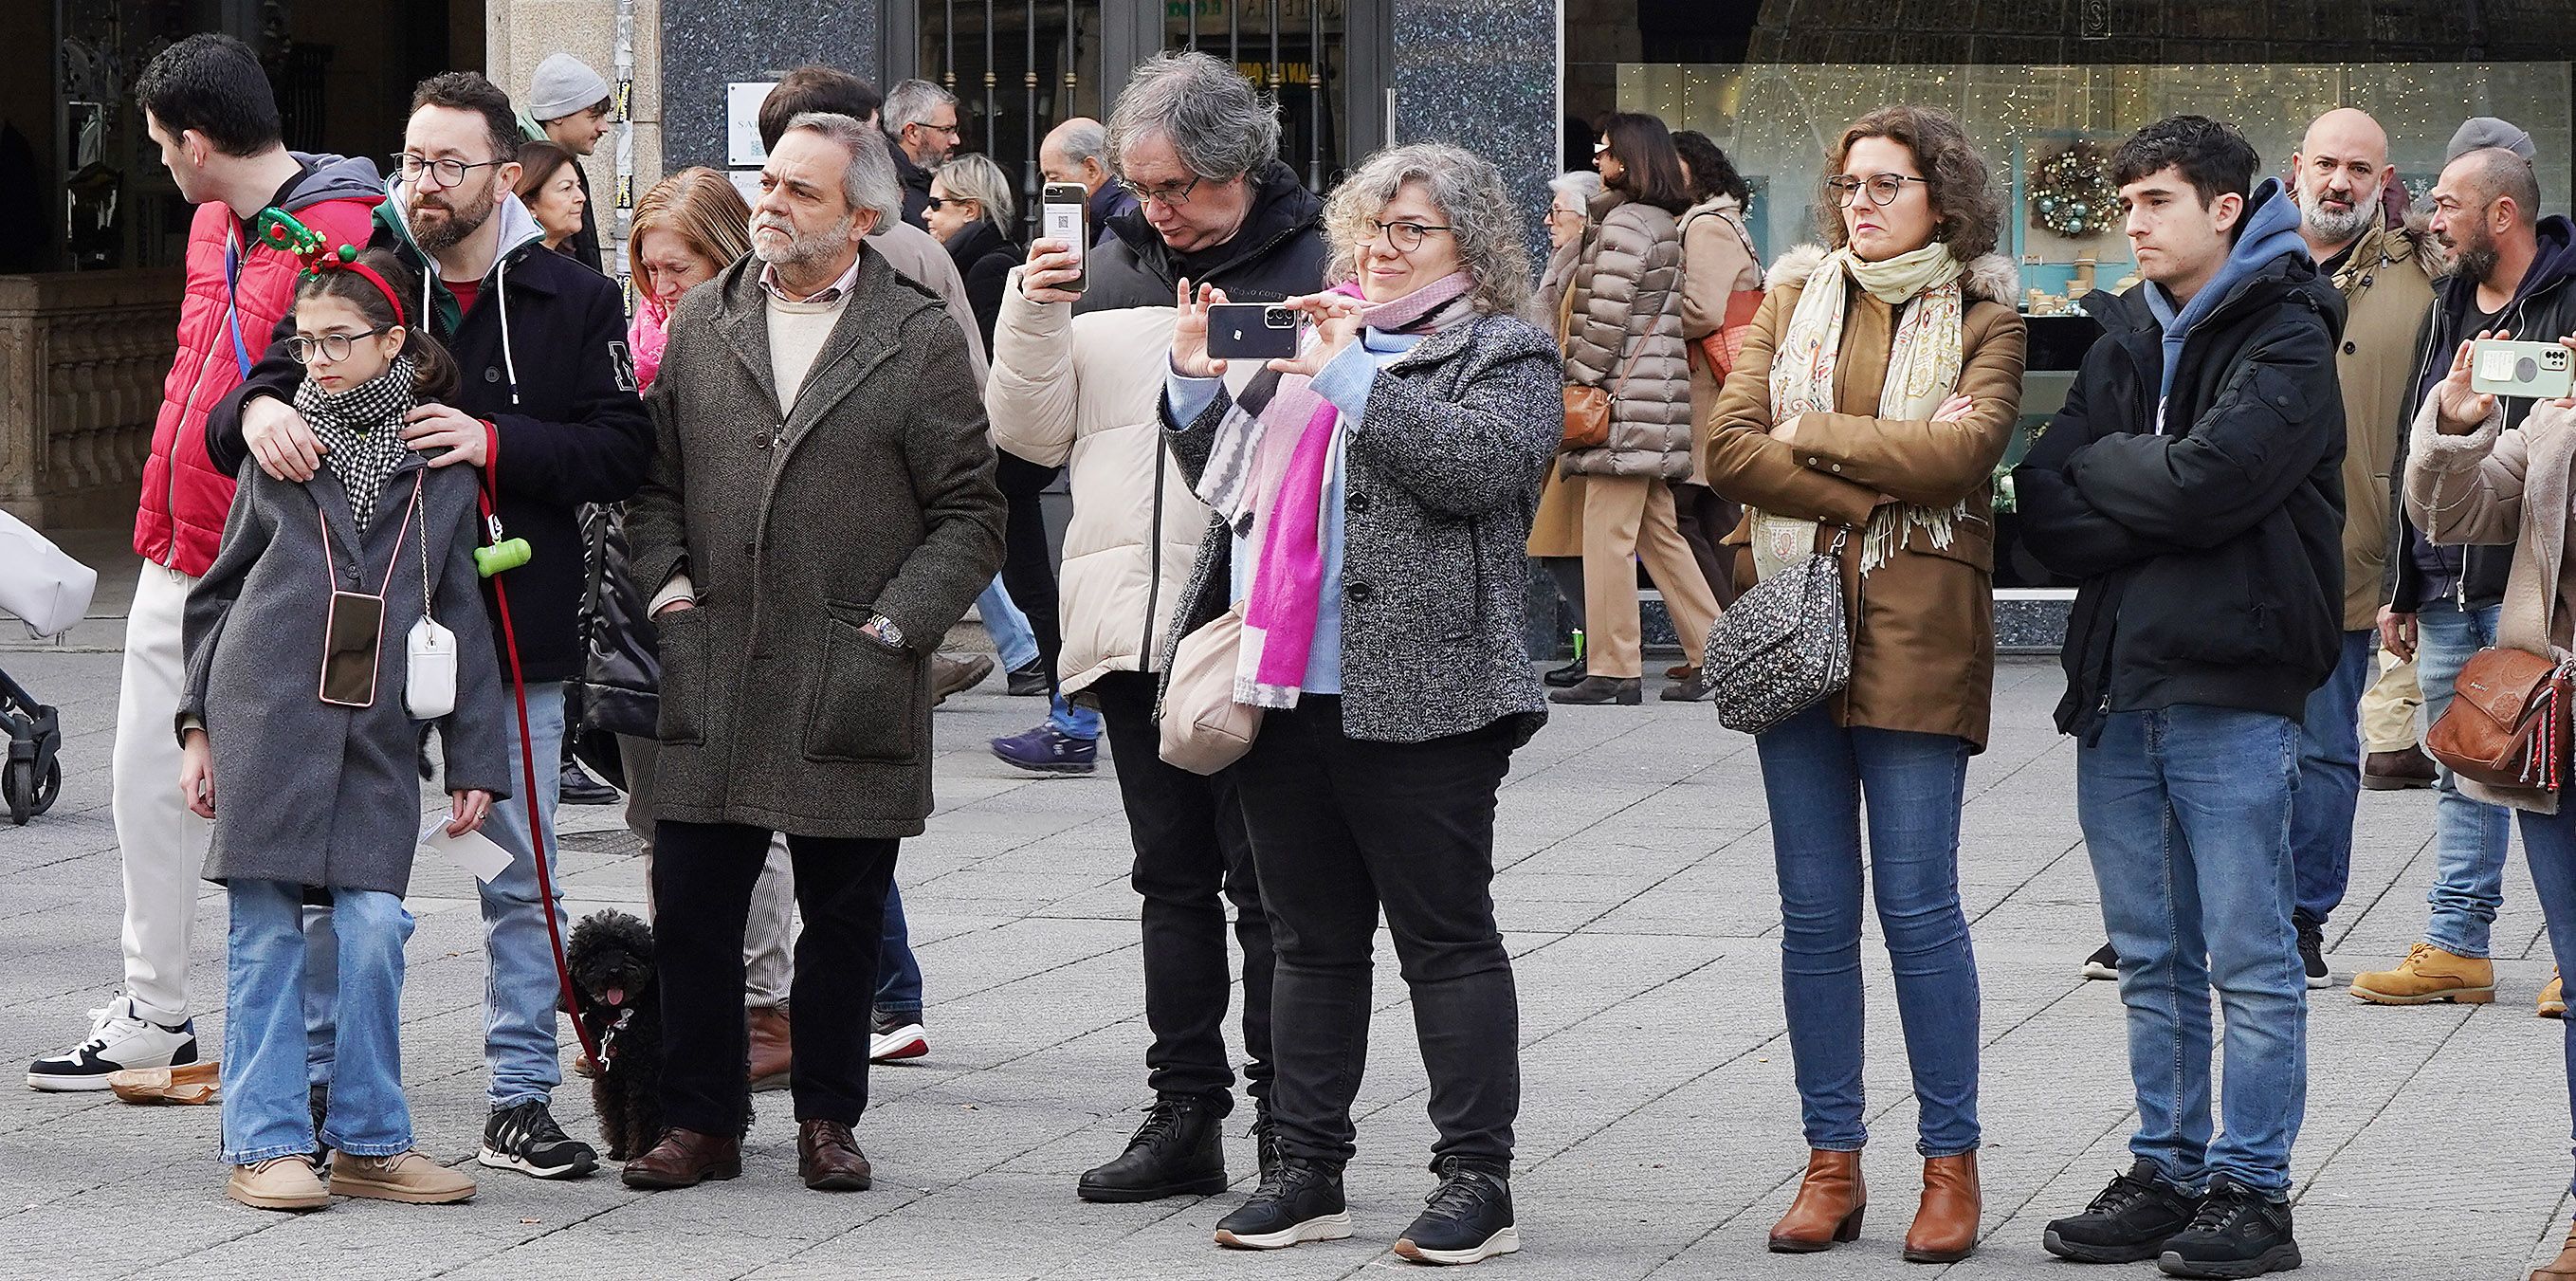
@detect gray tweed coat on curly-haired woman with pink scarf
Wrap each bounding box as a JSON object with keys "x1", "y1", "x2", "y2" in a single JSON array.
[{"x1": 1161, "y1": 315, "x2": 1563, "y2": 742}]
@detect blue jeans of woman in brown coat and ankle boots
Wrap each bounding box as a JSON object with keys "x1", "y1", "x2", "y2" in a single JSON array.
[{"x1": 1757, "y1": 706, "x2": 1979, "y2": 1158}]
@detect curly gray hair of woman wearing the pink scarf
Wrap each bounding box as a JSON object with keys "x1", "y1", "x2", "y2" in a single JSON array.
[{"x1": 1325, "y1": 142, "x2": 1530, "y2": 315}]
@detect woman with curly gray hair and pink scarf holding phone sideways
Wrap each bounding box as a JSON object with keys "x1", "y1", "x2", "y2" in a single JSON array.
[{"x1": 1164, "y1": 144, "x2": 1563, "y2": 1263}]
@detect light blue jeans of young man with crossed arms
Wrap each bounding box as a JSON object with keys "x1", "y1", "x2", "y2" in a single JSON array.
[{"x1": 2076, "y1": 706, "x2": 2308, "y2": 1199}]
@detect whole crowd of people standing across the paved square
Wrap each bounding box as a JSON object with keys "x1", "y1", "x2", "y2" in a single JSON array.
[{"x1": 28, "y1": 22, "x2": 2576, "y2": 1278}]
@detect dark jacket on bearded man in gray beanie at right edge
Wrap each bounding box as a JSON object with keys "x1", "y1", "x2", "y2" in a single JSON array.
[{"x1": 2388, "y1": 214, "x2": 2576, "y2": 613}]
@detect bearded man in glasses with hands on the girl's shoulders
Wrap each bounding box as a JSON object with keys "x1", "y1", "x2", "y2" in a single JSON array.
[{"x1": 206, "y1": 72, "x2": 651, "y2": 1178}]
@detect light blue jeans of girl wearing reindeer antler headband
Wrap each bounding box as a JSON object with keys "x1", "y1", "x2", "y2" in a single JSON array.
[{"x1": 222, "y1": 879, "x2": 412, "y2": 1165}]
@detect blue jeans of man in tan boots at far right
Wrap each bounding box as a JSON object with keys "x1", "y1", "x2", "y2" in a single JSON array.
[{"x1": 2417, "y1": 598, "x2": 2514, "y2": 956}]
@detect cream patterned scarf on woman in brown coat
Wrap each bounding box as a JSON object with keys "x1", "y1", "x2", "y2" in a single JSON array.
[{"x1": 1752, "y1": 243, "x2": 1968, "y2": 577}]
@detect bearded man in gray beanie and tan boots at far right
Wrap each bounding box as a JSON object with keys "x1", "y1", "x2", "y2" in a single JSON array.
[{"x1": 2352, "y1": 116, "x2": 2576, "y2": 1008}]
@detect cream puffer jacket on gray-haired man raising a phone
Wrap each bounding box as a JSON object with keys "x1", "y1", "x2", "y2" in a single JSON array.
[{"x1": 984, "y1": 268, "x2": 1220, "y2": 693}]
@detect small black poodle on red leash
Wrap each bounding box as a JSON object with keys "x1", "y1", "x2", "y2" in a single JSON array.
[{"x1": 564, "y1": 907, "x2": 752, "y2": 1160}]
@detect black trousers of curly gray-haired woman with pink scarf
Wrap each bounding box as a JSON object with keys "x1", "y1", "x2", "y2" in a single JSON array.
[{"x1": 1232, "y1": 693, "x2": 1520, "y2": 1170}]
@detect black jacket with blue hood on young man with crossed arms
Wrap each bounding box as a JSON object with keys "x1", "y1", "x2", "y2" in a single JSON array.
[{"x1": 2015, "y1": 180, "x2": 2344, "y2": 742}]
